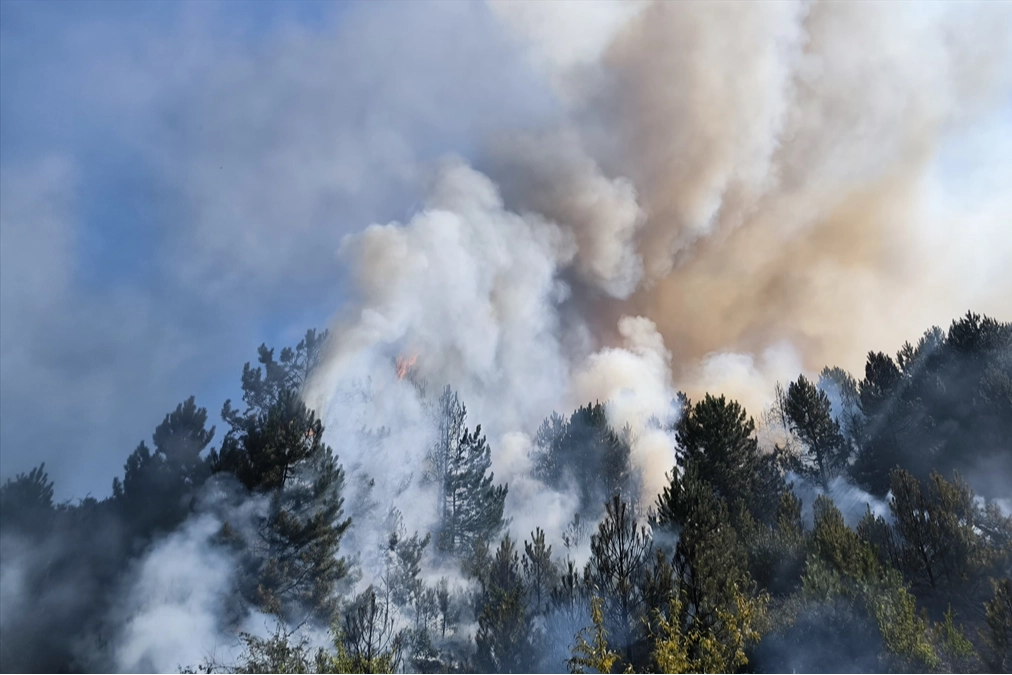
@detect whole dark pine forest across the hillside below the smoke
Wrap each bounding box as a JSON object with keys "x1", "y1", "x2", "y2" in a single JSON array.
[{"x1": 0, "y1": 314, "x2": 1012, "y2": 673}]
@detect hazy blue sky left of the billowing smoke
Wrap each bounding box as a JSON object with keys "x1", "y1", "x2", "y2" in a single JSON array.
[{"x1": 0, "y1": 0, "x2": 553, "y2": 498}]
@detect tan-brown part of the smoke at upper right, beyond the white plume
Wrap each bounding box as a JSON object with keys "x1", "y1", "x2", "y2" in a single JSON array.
[{"x1": 485, "y1": 2, "x2": 1012, "y2": 404}]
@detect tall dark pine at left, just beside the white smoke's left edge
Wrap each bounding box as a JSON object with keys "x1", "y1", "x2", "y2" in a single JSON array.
[{"x1": 208, "y1": 331, "x2": 351, "y2": 624}]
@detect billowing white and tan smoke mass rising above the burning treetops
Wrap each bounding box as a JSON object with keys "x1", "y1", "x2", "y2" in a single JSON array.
[{"x1": 307, "y1": 2, "x2": 1012, "y2": 525}]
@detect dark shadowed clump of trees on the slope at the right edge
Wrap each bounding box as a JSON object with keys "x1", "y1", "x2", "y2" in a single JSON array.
[{"x1": 852, "y1": 313, "x2": 1012, "y2": 495}]
